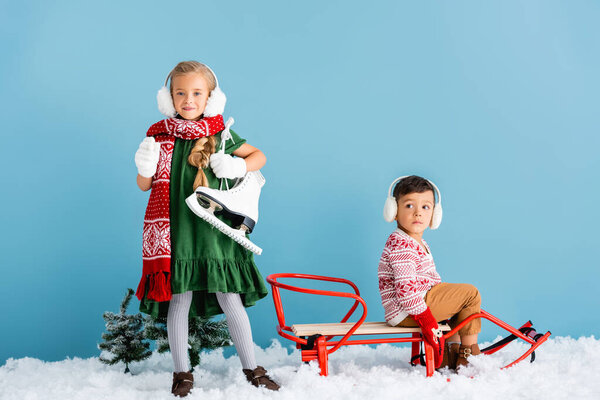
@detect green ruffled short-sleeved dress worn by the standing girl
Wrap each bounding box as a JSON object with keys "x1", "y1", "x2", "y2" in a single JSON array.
[{"x1": 140, "y1": 131, "x2": 268, "y2": 317}]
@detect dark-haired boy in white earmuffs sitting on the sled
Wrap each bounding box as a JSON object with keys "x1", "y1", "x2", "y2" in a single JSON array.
[{"x1": 378, "y1": 176, "x2": 481, "y2": 369}]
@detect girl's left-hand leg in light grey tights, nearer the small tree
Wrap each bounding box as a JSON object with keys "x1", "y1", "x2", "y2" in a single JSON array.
[{"x1": 167, "y1": 292, "x2": 193, "y2": 372}]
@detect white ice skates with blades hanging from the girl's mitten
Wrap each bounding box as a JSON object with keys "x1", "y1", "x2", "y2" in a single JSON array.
[{"x1": 185, "y1": 171, "x2": 265, "y2": 254}]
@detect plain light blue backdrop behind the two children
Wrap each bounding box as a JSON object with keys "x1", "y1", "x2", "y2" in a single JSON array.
[{"x1": 0, "y1": 1, "x2": 600, "y2": 362}]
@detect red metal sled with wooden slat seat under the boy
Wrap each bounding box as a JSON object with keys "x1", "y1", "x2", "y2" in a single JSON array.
[{"x1": 267, "y1": 273, "x2": 550, "y2": 376}]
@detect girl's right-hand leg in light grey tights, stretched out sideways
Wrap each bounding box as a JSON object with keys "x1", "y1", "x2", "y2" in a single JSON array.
[{"x1": 216, "y1": 293, "x2": 256, "y2": 370}]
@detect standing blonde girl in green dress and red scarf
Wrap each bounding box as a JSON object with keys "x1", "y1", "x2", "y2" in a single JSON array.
[{"x1": 135, "y1": 61, "x2": 279, "y2": 397}]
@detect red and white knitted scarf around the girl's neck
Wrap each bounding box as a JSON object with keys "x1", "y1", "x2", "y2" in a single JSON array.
[{"x1": 136, "y1": 115, "x2": 225, "y2": 301}]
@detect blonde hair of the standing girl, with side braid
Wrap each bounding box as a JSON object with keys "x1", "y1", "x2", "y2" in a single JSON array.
[{"x1": 167, "y1": 61, "x2": 217, "y2": 190}]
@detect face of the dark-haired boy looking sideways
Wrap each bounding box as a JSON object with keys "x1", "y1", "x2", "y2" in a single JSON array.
[{"x1": 396, "y1": 190, "x2": 435, "y2": 237}]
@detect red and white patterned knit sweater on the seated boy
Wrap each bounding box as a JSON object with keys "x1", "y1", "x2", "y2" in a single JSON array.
[{"x1": 378, "y1": 229, "x2": 442, "y2": 326}]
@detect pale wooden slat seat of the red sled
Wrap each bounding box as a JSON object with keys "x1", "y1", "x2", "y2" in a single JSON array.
[{"x1": 292, "y1": 321, "x2": 450, "y2": 336}]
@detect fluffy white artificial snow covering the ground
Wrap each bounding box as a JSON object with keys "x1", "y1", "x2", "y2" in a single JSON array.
[{"x1": 0, "y1": 337, "x2": 600, "y2": 400}]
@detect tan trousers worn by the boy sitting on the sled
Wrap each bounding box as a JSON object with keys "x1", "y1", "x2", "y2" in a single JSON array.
[{"x1": 397, "y1": 282, "x2": 481, "y2": 336}]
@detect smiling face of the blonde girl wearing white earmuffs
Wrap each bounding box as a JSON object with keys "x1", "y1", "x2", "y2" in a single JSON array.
[{"x1": 171, "y1": 72, "x2": 210, "y2": 120}]
